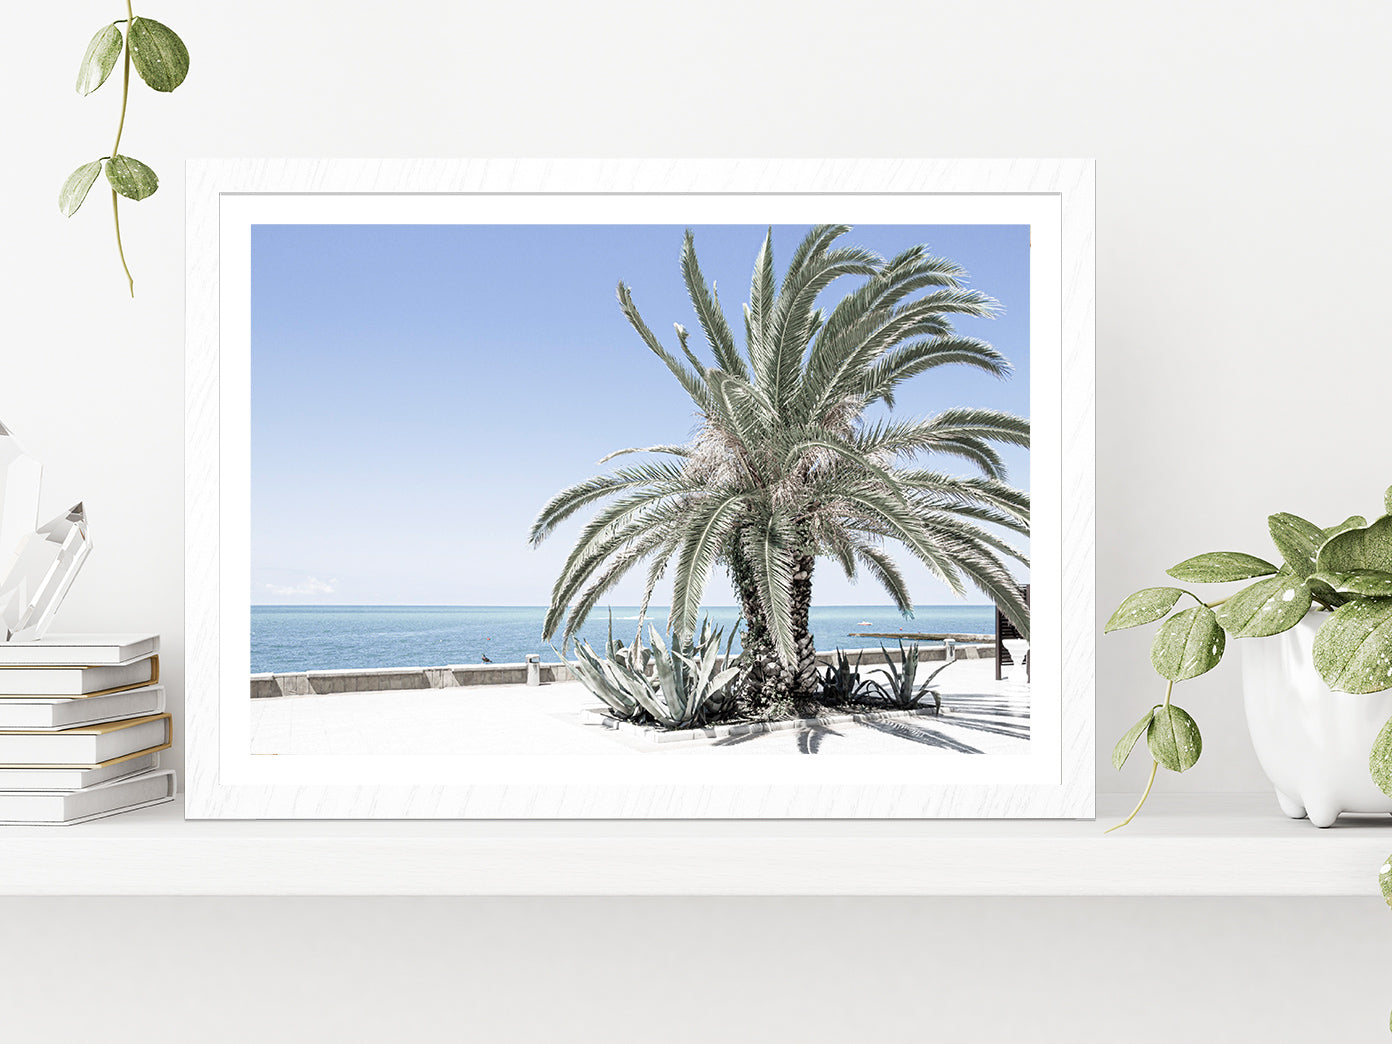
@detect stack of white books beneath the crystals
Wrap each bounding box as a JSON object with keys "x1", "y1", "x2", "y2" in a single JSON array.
[{"x1": 0, "y1": 635, "x2": 175, "y2": 824}]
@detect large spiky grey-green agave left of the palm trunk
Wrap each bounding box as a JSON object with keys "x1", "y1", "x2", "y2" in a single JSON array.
[{"x1": 576, "y1": 621, "x2": 739, "y2": 729}]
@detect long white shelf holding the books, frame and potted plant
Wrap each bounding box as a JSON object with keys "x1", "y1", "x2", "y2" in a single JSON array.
[{"x1": 0, "y1": 795, "x2": 1392, "y2": 896}]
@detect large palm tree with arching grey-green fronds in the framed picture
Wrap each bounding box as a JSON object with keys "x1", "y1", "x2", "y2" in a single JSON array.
[{"x1": 530, "y1": 226, "x2": 1029, "y2": 704}]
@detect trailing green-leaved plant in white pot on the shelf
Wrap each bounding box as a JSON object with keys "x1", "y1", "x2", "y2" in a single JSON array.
[{"x1": 1104, "y1": 489, "x2": 1392, "y2": 835}]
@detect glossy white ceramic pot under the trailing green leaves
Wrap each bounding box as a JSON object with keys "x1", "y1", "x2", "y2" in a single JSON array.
[{"x1": 1237, "y1": 612, "x2": 1392, "y2": 827}]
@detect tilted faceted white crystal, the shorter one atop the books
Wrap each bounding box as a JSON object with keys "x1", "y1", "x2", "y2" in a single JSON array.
[{"x1": 0, "y1": 504, "x2": 92, "y2": 642}]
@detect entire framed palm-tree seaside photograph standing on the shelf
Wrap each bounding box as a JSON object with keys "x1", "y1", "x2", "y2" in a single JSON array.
[{"x1": 187, "y1": 160, "x2": 1094, "y2": 818}]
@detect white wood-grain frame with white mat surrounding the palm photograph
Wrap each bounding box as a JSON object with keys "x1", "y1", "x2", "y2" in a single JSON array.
[{"x1": 185, "y1": 160, "x2": 1096, "y2": 818}]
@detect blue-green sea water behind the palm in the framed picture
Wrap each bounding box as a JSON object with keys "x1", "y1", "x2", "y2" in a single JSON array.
[{"x1": 251, "y1": 606, "x2": 995, "y2": 674}]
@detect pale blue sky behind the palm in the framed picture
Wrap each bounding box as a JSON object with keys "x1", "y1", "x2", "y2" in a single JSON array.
[{"x1": 251, "y1": 226, "x2": 1029, "y2": 606}]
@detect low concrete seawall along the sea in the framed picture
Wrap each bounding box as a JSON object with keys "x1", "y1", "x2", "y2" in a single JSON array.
[{"x1": 251, "y1": 643, "x2": 992, "y2": 700}]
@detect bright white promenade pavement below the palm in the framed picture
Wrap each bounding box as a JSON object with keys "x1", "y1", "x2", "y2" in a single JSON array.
[{"x1": 251, "y1": 660, "x2": 1030, "y2": 756}]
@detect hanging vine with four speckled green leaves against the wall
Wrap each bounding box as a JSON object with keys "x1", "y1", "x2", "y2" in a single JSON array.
[{"x1": 58, "y1": 0, "x2": 188, "y2": 298}]
